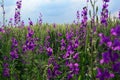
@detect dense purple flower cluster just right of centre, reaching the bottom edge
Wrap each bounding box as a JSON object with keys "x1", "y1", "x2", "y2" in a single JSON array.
[{"x1": 61, "y1": 30, "x2": 80, "y2": 80}]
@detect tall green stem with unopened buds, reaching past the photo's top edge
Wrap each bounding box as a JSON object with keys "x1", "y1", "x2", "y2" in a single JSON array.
[{"x1": 90, "y1": 0, "x2": 98, "y2": 80}]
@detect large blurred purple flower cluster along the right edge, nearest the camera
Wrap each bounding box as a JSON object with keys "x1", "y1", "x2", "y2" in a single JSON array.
[{"x1": 97, "y1": 25, "x2": 120, "y2": 80}]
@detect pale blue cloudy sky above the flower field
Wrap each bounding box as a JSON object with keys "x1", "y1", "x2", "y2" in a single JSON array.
[{"x1": 0, "y1": 0, "x2": 120, "y2": 24}]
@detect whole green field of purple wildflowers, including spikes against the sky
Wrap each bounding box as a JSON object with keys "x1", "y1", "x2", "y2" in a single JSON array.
[{"x1": 0, "y1": 0, "x2": 120, "y2": 80}]
